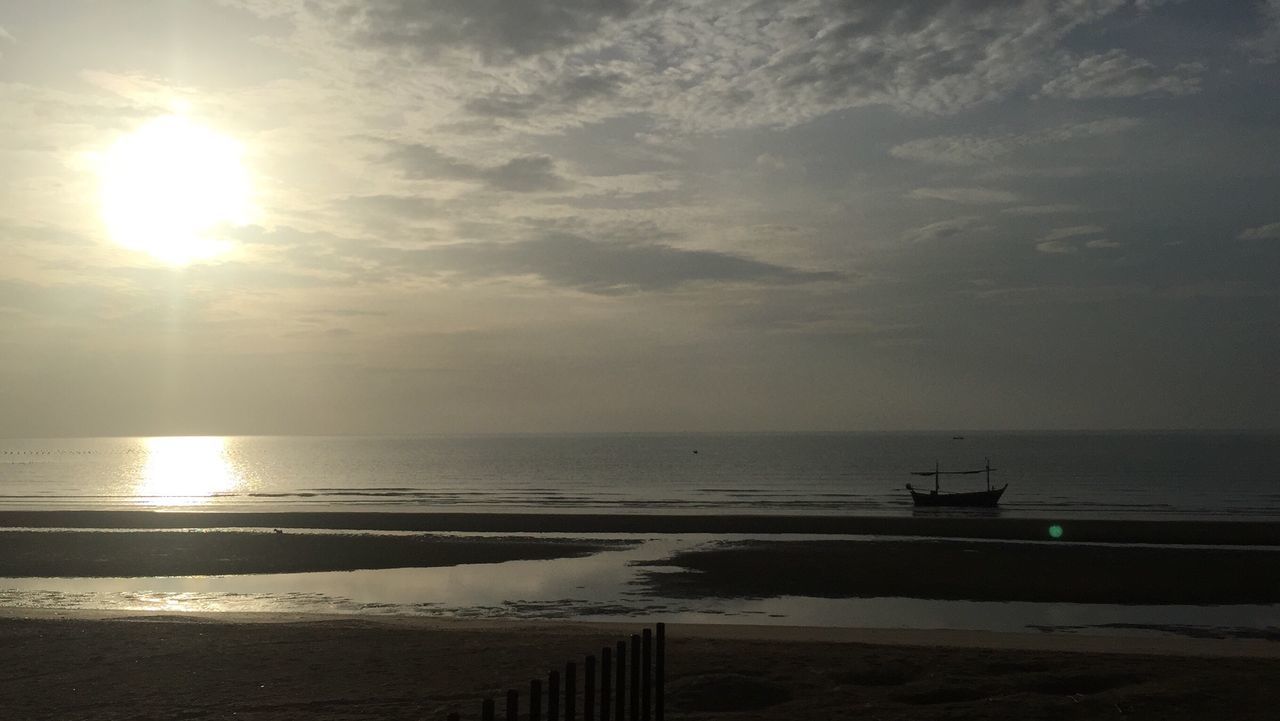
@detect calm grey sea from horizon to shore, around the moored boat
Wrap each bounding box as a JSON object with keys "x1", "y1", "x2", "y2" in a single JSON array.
[{"x1": 0, "y1": 432, "x2": 1280, "y2": 520}]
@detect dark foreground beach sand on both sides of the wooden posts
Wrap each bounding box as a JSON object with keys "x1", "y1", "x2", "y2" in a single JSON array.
[{"x1": 0, "y1": 612, "x2": 1280, "y2": 721}]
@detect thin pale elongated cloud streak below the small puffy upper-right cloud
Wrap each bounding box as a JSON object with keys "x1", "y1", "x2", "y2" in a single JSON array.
[{"x1": 888, "y1": 117, "x2": 1142, "y2": 165}]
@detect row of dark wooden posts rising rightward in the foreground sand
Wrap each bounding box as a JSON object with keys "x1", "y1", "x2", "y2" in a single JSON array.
[{"x1": 448, "y1": 624, "x2": 667, "y2": 721}]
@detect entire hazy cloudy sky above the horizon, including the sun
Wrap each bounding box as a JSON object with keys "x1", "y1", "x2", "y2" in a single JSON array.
[{"x1": 0, "y1": 0, "x2": 1280, "y2": 437}]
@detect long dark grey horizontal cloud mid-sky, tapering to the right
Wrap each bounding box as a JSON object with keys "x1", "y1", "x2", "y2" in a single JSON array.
[{"x1": 388, "y1": 234, "x2": 844, "y2": 295}]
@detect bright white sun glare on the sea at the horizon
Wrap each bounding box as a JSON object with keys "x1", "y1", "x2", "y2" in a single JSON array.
[{"x1": 134, "y1": 435, "x2": 244, "y2": 506}]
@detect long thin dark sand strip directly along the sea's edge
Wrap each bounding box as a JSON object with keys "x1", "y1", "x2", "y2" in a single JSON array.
[{"x1": 0, "y1": 510, "x2": 1280, "y2": 546}]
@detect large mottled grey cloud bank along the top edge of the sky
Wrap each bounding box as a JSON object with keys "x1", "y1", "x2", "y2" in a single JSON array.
[{"x1": 254, "y1": 0, "x2": 1130, "y2": 133}]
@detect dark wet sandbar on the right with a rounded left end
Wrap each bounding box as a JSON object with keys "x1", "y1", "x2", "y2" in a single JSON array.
[{"x1": 645, "y1": 540, "x2": 1280, "y2": 604}]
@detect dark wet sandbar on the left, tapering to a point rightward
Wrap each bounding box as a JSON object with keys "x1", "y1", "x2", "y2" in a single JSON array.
[{"x1": 0, "y1": 530, "x2": 628, "y2": 578}]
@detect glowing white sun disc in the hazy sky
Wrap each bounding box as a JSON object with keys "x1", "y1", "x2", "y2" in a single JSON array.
[{"x1": 99, "y1": 115, "x2": 251, "y2": 265}]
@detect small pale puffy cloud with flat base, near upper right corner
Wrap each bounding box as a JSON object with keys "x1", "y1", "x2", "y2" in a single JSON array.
[{"x1": 1041, "y1": 49, "x2": 1203, "y2": 100}]
